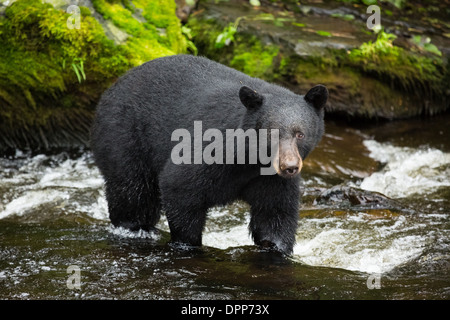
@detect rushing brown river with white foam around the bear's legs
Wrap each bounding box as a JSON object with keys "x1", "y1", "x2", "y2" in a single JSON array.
[{"x1": 0, "y1": 115, "x2": 450, "y2": 299}]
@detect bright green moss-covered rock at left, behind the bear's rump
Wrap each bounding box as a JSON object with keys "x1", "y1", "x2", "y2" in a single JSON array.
[{"x1": 0, "y1": 0, "x2": 187, "y2": 152}]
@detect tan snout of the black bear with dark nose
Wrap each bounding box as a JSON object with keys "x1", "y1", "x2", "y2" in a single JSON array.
[{"x1": 274, "y1": 139, "x2": 303, "y2": 178}]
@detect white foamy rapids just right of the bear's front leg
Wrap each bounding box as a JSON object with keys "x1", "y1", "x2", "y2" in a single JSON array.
[{"x1": 294, "y1": 213, "x2": 429, "y2": 273}]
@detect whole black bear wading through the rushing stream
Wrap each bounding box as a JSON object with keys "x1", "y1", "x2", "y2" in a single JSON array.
[{"x1": 91, "y1": 55, "x2": 328, "y2": 254}]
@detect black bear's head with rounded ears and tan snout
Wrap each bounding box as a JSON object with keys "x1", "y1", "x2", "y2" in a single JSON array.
[{"x1": 239, "y1": 85, "x2": 328, "y2": 178}]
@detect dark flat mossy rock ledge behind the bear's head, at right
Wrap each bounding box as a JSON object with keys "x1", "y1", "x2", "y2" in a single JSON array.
[{"x1": 188, "y1": 0, "x2": 450, "y2": 120}]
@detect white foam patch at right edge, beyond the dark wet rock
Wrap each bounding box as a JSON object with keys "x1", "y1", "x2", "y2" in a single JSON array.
[{"x1": 360, "y1": 140, "x2": 450, "y2": 198}]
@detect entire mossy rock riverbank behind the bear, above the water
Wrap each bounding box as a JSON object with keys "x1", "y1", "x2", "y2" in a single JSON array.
[{"x1": 0, "y1": 0, "x2": 450, "y2": 153}]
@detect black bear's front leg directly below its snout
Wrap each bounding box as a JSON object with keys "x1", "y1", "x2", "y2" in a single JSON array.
[{"x1": 243, "y1": 175, "x2": 300, "y2": 254}]
